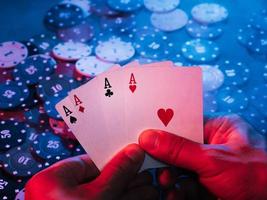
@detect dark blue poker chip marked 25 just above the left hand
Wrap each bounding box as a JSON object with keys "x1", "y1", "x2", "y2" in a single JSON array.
[{"x1": 31, "y1": 133, "x2": 70, "y2": 160}]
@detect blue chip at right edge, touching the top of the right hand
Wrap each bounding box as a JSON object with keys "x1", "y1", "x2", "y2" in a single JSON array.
[{"x1": 241, "y1": 106, "x2": 267, "y2": 134}]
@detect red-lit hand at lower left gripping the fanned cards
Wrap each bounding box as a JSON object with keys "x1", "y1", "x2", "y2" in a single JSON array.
[{"x1": 25, "y1": 145, "x2": 158, "y2": 200}]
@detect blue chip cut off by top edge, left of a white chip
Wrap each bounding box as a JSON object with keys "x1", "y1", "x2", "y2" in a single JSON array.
[{"x1": 107, "y1": 0, "x2": 144, "y2": 12}]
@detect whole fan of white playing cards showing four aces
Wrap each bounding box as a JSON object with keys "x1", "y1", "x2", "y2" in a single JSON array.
[{"x1": 56, "y1": 62, "x2": 203, "y2": 170}]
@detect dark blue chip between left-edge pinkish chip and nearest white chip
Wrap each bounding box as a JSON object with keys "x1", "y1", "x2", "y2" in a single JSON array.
[{"x1": 26, "y1": 34, "x2": 59, "y2": 54}]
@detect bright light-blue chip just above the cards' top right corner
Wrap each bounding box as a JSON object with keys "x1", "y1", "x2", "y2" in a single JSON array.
[{"x1": 181, "y1": 39, "x2": 220, "y2": 62}]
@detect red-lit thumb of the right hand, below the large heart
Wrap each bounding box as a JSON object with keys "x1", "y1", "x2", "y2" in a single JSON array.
[{"x1": 139, "y1": 130, "x2": 208, "y2": 173}]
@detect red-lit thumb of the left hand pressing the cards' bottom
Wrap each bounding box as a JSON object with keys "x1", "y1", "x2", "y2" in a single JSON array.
[{"x1": 92, "y1": 144, "x2": 145, "y2": 196}]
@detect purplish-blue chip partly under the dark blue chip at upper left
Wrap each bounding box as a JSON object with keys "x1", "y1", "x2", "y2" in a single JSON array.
[{"x1": 57, "y1": 22, "x2": 94, "y2": 42}]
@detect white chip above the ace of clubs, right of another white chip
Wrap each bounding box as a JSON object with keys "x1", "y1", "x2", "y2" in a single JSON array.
[{"x1": 95, "y1": 37, "x2": 135, "y2": 63}]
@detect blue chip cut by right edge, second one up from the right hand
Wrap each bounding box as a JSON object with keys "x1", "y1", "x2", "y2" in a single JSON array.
[{"x1": 250, "y1": 84, "x2": 267, "y2": 117}]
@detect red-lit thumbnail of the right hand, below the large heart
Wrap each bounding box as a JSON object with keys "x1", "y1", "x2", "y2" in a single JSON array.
[{"x1": 139, "y1": 130, "x2": 159, "y2": 150}]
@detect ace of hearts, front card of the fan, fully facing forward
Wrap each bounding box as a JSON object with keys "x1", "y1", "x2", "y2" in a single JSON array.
[{"x1": 124, "y1": 67, "x2": 203, "y2": 143}]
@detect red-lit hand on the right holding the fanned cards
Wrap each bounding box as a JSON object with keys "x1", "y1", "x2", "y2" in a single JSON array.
[{"x1": 139, "y1": 115, "x2": 267, "y2": 200}]
